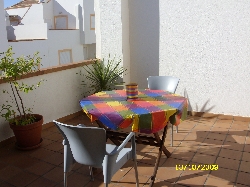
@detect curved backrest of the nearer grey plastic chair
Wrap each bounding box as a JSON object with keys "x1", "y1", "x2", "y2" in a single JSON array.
[{"x1": 54, "y1": 121, "x2": 106, "y2": 168}]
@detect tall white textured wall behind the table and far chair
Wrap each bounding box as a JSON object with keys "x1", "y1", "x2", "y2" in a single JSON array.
[{"x1": 95, "y1": 0, "x2": 250, "y2": 117}]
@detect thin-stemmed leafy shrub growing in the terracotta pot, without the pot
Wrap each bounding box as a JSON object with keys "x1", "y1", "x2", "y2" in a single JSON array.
[{"x1": 0, "y1": 47, "x2": 43, "y2": 125}]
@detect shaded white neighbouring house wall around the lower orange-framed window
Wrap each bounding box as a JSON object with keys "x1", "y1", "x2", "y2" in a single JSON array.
[{"x1": 9, "y1": 30, "x2": 88, "y2": 68}]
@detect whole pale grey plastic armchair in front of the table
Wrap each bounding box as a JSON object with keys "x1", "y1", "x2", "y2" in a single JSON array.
[{"x1": 53, "y1": 120, "x2": 139, "y2": 187}]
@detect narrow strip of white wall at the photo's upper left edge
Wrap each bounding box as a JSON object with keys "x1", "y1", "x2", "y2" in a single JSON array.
[{"x1": 0, "y1": 1, "x2": 8, "y2": 53}]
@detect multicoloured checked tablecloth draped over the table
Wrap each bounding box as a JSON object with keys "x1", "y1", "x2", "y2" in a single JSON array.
[{"x1": 80, "y1": 90, "x2": 187, "y2": 134}]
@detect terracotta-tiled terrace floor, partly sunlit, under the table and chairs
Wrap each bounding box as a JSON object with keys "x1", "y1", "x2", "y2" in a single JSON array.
[{"x1": 0, "y1": 113, "x2": 250, "y2": 187}]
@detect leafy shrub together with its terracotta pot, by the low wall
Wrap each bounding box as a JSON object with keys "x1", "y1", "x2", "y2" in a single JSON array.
[{"x1": 0, "y1": 47, "x2": 43, "y2": 150}]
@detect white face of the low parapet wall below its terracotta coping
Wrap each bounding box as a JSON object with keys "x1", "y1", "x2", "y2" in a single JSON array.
[{"x1": 0, "y1": 67, "x2": 89, "y2": 142}]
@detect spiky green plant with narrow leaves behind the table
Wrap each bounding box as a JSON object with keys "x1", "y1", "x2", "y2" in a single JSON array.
[{"x1": 80, "y1": 56, "x2": 127, "y2": 93}]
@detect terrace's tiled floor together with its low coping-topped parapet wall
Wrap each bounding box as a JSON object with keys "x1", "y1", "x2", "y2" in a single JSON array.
[{"x1": 0, "y1": 61, "x2": 250, "y2": 187}]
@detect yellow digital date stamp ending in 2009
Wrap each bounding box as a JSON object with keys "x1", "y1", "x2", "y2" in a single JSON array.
[{"x1": 175, "y1": 164, "x2": 219, "y2": 170}]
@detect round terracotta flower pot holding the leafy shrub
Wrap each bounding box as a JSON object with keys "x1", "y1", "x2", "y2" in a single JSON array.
[{"x1": 10, "y1": 114, "x2": 43, "y2": 150}]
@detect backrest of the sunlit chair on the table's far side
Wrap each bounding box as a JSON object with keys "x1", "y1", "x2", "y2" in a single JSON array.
[{"x1": 148, "y1": 76, "x2": 180, "y2": 93}]
